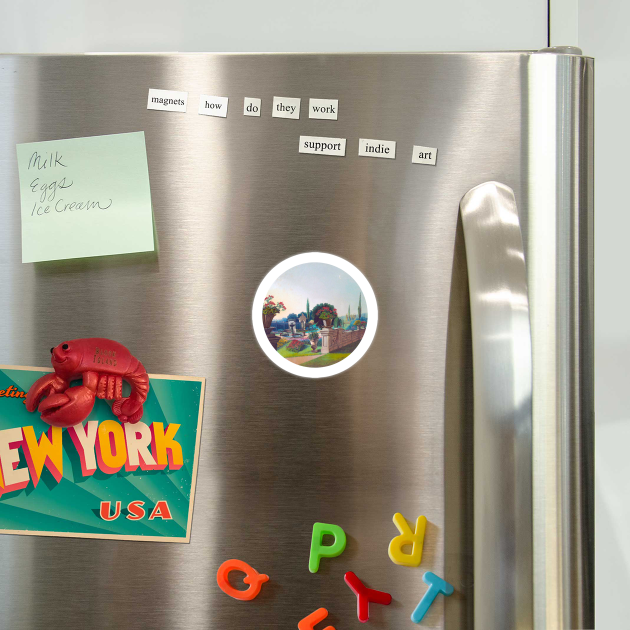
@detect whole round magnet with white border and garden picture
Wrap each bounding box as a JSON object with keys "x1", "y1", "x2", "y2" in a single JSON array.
[{"x1": 252, "y1": 252, "x2": 378, "y2": 378}]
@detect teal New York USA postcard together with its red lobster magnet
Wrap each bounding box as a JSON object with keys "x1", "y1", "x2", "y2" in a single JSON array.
[{"x1": 0, "y1": 338, "x2": 205, "y2": 542}]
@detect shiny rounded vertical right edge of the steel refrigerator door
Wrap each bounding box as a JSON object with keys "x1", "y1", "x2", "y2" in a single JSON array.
[{"x1": 525, "y1": 53, "x2": 595, "y2": 628}]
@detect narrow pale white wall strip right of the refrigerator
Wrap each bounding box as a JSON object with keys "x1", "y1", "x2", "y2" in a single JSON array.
[{"x1": 578, "y1": 0, "x2": 630, "y2": 629}]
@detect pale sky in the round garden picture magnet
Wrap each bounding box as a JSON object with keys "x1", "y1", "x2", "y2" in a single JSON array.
[{"x1": 267, "y1": 263, "x2": 367, "y2": 319}]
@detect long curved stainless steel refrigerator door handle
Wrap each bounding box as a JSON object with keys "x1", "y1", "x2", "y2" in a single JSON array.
[{"x1": 460, "y1": 182, "x2": 533, "y2": 630}]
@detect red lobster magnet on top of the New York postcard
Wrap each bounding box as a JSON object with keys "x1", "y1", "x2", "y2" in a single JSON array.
[{"x1": 26, "y1": 337, "x2": 149, "y2": 427}]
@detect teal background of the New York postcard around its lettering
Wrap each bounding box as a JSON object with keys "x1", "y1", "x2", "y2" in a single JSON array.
[{"x1": 0, "y1": 368, "x2": 203, "y2": 542}]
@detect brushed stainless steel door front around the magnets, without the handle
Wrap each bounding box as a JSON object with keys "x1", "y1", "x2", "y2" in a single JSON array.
[{"x1": 0, "y1": 53, "x2": 592, "y2": 630}]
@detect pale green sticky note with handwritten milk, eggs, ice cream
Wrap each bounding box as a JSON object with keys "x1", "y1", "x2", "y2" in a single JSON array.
[{"x1": 17, "y1": 131, "x2": 154, "y2": 263}]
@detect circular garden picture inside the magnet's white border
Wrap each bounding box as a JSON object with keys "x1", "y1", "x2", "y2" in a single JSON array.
[{"x1": 260, "y1": 262, "x2": 368, "y2": 368}]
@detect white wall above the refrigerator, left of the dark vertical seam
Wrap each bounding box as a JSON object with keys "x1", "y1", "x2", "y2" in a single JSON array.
[{"x1": 0, "y1": 0, "x2": 547, "y2": 53}]
